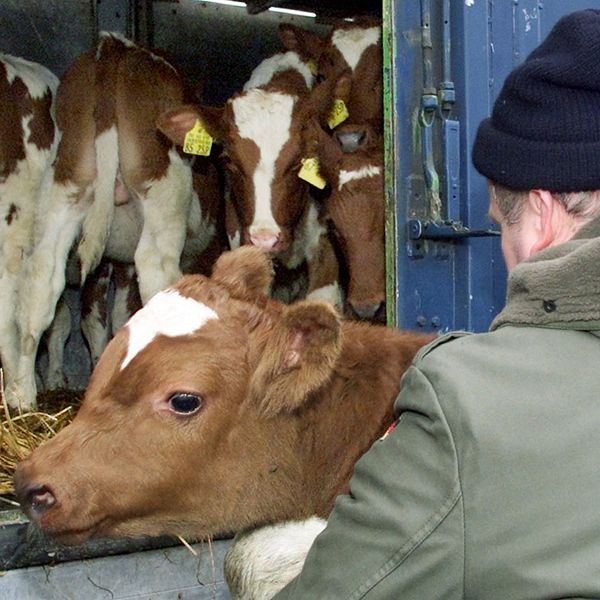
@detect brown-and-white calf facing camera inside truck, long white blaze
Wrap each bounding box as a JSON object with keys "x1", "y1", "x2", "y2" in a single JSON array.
[{"x1": 158, "y1": 51, "x2": 341, "y2": 305}]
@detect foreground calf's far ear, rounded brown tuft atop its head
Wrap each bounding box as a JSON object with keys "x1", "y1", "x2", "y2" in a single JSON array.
[{"x1": 211, "y1": 246, "x2": 273, "y2": 302}]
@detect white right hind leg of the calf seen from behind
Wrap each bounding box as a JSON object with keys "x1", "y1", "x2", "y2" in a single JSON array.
[{"x1": 135, "y1": 150, "x2": 192, "y2": 303}]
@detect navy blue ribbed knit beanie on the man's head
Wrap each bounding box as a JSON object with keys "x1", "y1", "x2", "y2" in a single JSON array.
[{"x1": 473, "y1": 9, "x2": 600, "y2": 192}]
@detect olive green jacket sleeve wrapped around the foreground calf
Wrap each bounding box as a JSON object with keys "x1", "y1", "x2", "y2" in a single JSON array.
[{"x1": 275, "y1": 366, "x2": 464, "y2": 600}]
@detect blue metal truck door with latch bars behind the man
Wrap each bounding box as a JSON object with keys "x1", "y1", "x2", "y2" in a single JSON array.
[{"x1": 383, "y1": 0, "x2": 600, "y2": 331}]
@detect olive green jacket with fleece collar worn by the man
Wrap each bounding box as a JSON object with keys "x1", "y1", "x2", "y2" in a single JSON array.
[{"x1": 276, "y1": 217, "x2": 600, "y2": 600}]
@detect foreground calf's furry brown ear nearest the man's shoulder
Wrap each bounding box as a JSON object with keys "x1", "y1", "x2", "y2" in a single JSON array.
[{"x1": 250, "y1": 300, "x2": 341, "y2": 417}]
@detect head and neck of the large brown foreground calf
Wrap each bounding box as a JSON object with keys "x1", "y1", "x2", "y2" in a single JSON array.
[{"x1": 15, "y1": 247, "x2": 430, "y2": 542}]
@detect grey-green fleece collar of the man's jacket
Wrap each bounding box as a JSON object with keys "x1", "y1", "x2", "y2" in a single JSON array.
[{"x1": 491, "y1": 217, "x2": 600, "y2": 331}]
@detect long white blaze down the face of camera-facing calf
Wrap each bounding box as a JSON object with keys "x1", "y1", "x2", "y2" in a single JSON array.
[{"x1": 232, "y1": 89, "x2": 297, "y2": 232}]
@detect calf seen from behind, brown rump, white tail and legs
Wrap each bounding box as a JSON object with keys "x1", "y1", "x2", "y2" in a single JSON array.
[{"x1": 7, "y1": 34, "x2": 195, "y2": 407}]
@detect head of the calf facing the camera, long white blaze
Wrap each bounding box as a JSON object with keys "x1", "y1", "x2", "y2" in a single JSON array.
[{"x1": 157, "y1": 57, "x2": 336, "y2": 255}]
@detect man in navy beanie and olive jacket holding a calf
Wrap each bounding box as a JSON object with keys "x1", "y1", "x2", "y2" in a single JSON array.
[{"x1": 275, "y1": 10, "x2": 600, "y2": 600}]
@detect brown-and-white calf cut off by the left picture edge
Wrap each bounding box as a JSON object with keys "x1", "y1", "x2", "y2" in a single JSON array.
[{"x1": 0, "y1": 54, "x2": 58, "y2": 404}]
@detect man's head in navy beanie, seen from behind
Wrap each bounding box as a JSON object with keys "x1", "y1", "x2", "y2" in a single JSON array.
[{"x1": 473, "y1": 10, "x2": 600, "y2": 271}]
